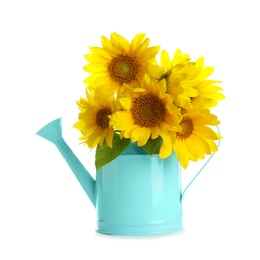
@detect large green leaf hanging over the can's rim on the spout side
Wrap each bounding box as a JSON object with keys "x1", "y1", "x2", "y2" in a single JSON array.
[{"x1": 95, "y1": 134, "x2": 130, "y2": 171}]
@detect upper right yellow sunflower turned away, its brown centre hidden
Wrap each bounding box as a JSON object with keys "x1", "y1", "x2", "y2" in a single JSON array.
[{"x1": 159, "y1": 49, "x2": 224, "y2": 109}]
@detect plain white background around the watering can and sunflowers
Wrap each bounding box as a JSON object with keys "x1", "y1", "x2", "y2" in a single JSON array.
[{"x1": 0, "y1": 0, "x2": 260, "y2": 260}]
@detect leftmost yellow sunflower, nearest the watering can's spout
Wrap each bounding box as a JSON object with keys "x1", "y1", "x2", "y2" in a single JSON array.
[{"x1": 74, "y1": 92, "x2": 116, "y2": 148}]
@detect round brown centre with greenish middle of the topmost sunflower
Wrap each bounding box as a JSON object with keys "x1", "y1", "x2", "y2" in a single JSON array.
[{"x1": 108, "y1": 55, "x2": 139, "y2": 85}]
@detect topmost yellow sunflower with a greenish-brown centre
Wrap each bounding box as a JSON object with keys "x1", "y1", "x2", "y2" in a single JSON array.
[{"x1": 84, "y1": 33, "x2": 160, "y2": 92}]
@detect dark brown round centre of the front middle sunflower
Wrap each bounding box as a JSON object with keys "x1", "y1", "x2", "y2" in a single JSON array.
[{"x1": 130, "y1": 94, "x2": 166, "y2": 127}]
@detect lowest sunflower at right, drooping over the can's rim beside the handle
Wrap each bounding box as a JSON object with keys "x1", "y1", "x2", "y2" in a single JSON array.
[{"x1": 173, "y1": 109, "x2": 221, "y2": 169}]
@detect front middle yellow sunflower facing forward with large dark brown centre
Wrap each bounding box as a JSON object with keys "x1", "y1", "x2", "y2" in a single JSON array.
[{"x1": 109, "y1": 74, "x2": 181, "y2": 158}]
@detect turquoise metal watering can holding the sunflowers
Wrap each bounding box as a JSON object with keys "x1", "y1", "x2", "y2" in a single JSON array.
[{"x1": 37, "y1": 118, "x2": 219, "y2": 236}]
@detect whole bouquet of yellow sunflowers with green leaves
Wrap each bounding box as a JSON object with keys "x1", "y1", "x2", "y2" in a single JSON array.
[{"x1": 74, "y1": 33, "x2": 224, "y2": 170}]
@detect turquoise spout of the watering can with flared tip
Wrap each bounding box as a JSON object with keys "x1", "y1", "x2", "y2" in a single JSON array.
[{"x1": 36, "y1": 118, "x2": 96, "y2": 207}]
